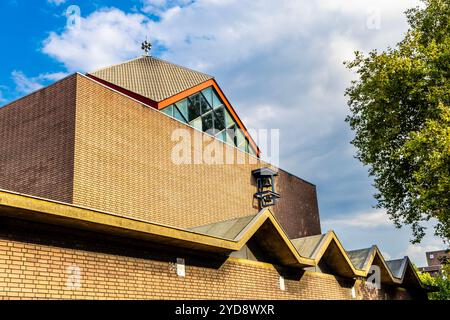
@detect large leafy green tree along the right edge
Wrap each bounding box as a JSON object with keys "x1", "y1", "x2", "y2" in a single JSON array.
[{"x1": 345, "y1": 0, "x2": 450, "y2": 243}]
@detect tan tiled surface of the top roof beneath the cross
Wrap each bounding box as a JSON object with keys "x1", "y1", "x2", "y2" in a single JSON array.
[{"x1": 88, "y1": 56, "x2": 213, "y2": 102}]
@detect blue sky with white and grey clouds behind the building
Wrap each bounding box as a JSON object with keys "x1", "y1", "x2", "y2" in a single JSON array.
[{"x1": 0, "y1": 0, "x2": 444, "y2": 266}]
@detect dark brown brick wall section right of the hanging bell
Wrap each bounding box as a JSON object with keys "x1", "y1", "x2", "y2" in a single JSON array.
[{"x1": 274, "y1": 170, "x2": 321, "y2": 239}]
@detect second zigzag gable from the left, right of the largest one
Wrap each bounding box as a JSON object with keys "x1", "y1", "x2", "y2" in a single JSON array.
[{"x1": 292, "y1": 231, "x2": 357, "y2": 278}]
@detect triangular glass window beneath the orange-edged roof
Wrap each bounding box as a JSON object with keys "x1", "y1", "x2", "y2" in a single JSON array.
[{"x1": 161, "y1": 87, "x2": 256, "y2": 156}]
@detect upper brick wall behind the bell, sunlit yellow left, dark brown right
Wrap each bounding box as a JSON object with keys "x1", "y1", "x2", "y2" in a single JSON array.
[{"x1": 74, "y1": 77, "x2": 320, "y2": 235}]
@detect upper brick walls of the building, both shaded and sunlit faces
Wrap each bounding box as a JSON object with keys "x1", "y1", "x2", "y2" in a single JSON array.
[{"x1": 0, "y1": 74, "x2": 320, "y2": 236}]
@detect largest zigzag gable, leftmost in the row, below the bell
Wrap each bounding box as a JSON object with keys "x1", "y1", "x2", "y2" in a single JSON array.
[{"x1": 190, "y1": 208, "x2": 314, "y2": 267}]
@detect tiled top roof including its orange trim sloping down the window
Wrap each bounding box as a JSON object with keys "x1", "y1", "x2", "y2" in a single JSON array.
[{"x1": 86, "y1": 56, "x2": 260, "y2": 156}]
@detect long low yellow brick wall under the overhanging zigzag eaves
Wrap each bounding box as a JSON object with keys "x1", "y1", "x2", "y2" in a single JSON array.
[{"x1": 0, "y1": 220, "x2": 353, "y2": 299}]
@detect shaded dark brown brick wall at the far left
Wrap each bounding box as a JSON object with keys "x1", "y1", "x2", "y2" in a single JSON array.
[{"x1": 0, "y1": 76, "x2": 76, "y2": 202}]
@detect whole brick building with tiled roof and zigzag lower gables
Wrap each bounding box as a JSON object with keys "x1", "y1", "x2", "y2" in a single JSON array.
[{"x1": 0, "y1": 56, "x2": 428, "y2": 299}]
